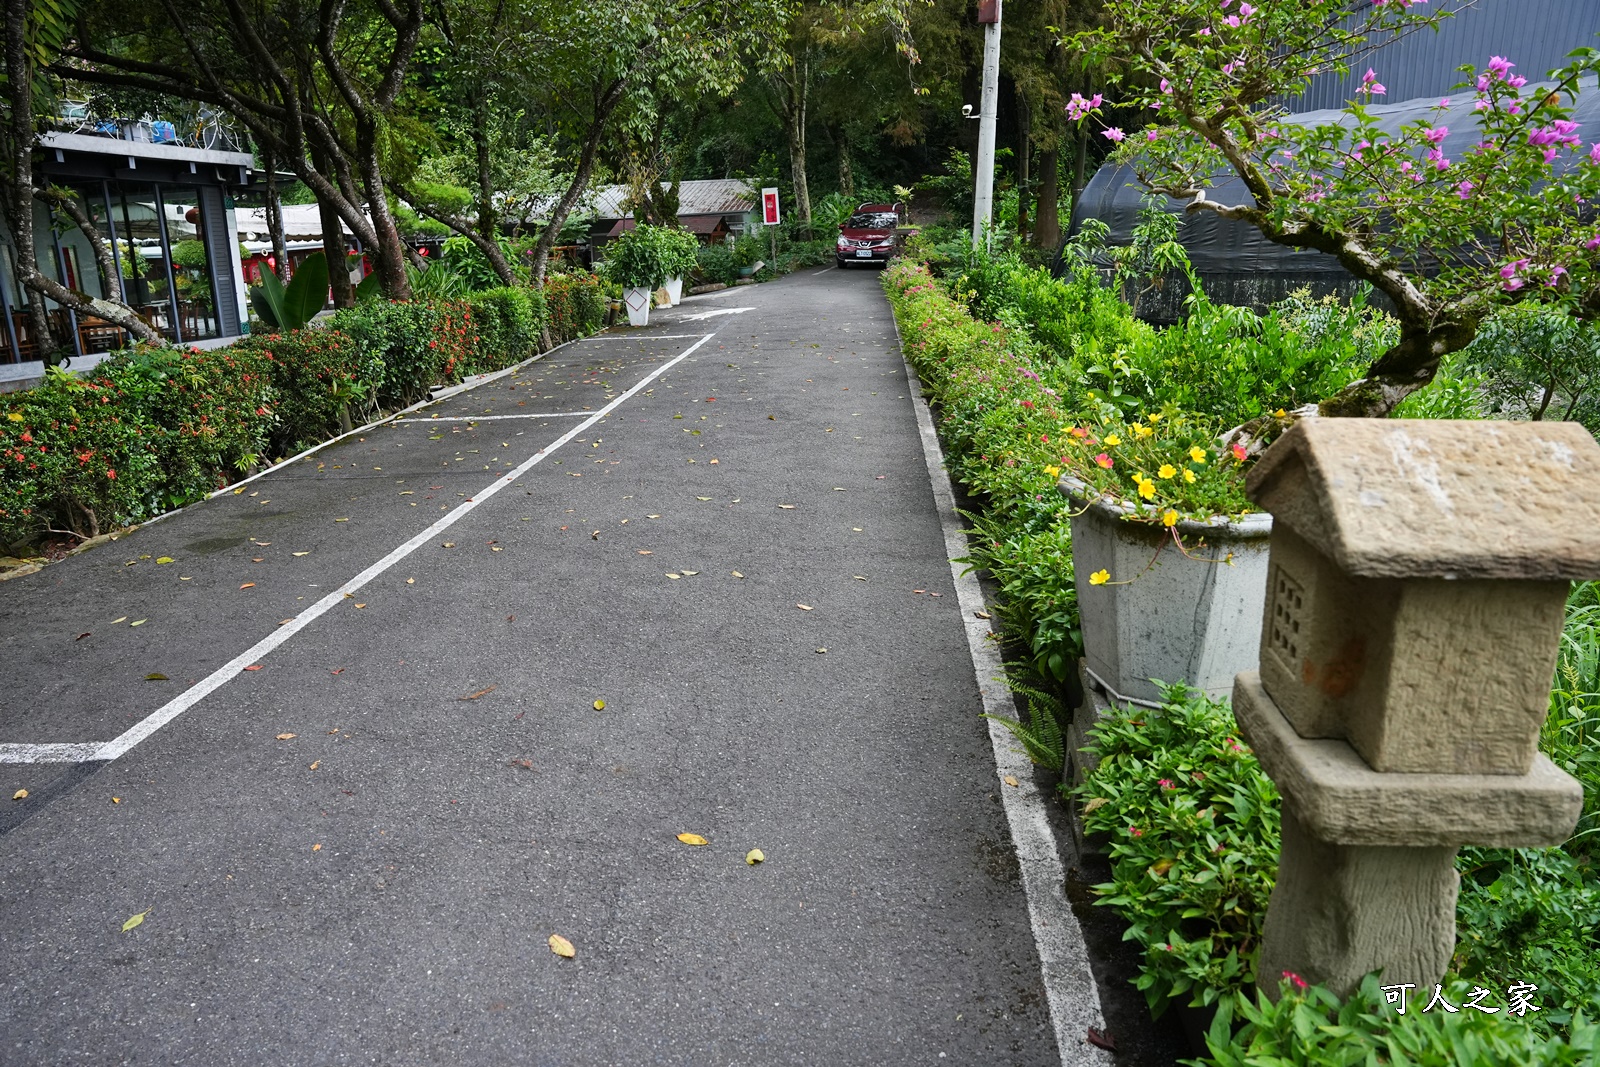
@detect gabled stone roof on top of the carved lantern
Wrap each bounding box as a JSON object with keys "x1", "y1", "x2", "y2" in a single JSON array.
[{"x1": 1246, "y1": 419, "x2": 1600, "y2": 579}]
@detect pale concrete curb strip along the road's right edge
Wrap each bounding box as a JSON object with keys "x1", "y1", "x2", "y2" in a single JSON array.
[{"x1": 890, "y1": 295, "x2": 1114, "y2": 1067}]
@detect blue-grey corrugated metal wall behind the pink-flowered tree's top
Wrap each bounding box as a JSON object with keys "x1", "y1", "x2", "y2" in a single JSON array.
[{"x1": 1283, "y1": 0, "x2": 1600, "y2": 112}]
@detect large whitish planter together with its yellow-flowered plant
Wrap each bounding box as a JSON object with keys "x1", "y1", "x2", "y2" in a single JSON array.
[{"x1": 1059, "y1": 409, "x2": 1272, "y2": 707}]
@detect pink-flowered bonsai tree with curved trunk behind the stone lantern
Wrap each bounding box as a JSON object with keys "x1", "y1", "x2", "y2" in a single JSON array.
[{"x1": 1067, "y1": 0, "x2": 1600, "y2": 428}]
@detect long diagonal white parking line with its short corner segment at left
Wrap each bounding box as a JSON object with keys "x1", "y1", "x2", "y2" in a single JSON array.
[{"x1": 0, "y1": 333, "x2": 715, "y2": 763}]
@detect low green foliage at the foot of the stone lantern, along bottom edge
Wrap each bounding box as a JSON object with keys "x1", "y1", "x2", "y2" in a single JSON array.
[{"x1": 1184, "y1": 974, "x2": 1600, "y2": 1067}]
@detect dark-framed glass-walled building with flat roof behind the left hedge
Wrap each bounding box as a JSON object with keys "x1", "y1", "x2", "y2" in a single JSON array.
[{"x1": 0, "y1": 117, "x2": 258, "y2": 365}]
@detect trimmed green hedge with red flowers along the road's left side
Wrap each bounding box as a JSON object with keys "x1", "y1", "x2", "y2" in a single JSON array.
[{"x1": 0, "y1": 287, "x2": 563, "y2": 544}]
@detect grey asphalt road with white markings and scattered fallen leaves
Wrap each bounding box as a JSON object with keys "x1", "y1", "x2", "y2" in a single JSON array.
[{"x1": 0, "y1": 270, "x2": 1059, "y2": 1065}]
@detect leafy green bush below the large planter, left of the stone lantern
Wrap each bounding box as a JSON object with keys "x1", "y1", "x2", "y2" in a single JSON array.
[{"x1": 1074, "y1": 685, "x2": 1278, "y2": 1014}]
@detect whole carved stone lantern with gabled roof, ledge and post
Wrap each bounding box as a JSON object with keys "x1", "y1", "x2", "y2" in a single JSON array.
[{"x1": 1234, "y1": 419, "x2": 1600, "y2": 995}]
